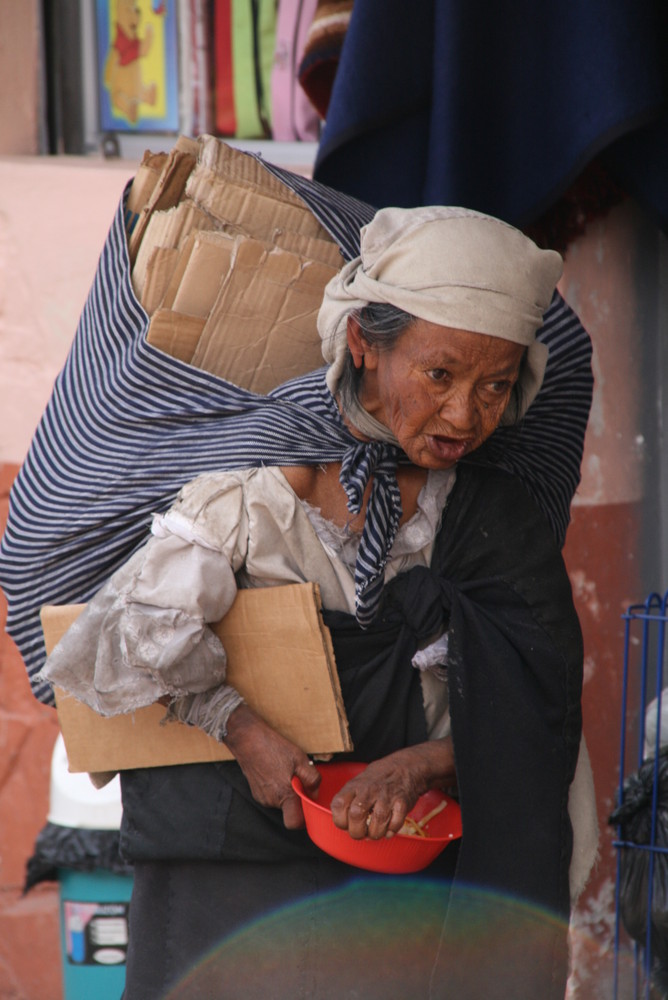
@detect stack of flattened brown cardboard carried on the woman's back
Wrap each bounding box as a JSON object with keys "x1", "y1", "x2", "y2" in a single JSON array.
[{"x1": 126, "y1": 136, "x2": 343, "y2": 393}]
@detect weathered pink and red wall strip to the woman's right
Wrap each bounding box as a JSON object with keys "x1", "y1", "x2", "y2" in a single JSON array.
[{"x1": 562, "y1": 203, "x2": 665, "y2": 1000}]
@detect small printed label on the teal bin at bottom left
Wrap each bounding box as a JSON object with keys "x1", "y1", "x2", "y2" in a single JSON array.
[{"x1": 63, "y1": 900, "x2": 129, "y2": 965}]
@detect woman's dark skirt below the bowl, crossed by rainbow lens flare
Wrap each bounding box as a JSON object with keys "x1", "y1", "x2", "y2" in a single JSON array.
[{"x1": 124, "y1": 845, "x2": 457, "y2": 1000}]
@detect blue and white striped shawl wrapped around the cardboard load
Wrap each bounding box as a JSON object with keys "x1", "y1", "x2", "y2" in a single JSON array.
[{"x1": 0, "y1": 164, "x2": 592, "y2": 703}]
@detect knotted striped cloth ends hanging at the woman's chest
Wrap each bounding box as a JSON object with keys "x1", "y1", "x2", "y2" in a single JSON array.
[{"x1": 339, "y1": 441, "x2": 401, "y2": 628}]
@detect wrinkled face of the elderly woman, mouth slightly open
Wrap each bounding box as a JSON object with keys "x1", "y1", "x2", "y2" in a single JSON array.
[{"x1": 348, "y1": 319, "x2": 525, "y2": 469}]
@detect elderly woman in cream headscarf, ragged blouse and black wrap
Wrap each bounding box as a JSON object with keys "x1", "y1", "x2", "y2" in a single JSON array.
[{"x1": 36, "y1": 207, "x2": 582, "y2": 1000}]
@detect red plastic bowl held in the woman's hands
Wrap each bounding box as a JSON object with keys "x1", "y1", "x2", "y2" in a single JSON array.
[{"x1": 292, "y1": 761, "x2": 462, "y2": 874}]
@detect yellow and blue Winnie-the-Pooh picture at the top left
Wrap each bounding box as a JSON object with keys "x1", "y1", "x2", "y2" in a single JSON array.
[{"x1": 96, "y1": 0, "x2": 179, "y2": 132}]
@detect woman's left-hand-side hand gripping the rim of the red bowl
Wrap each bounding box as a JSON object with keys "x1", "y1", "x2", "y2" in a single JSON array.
[{"x1": 225, "y1": 705, "x2": 320, "y2": 830}]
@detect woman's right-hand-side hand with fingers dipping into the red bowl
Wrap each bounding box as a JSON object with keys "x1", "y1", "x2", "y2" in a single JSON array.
[{"x1": 332, "y1": 737, "x2": 455, "y2": 840}]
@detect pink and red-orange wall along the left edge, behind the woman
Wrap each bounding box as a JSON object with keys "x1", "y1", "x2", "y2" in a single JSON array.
[{"x1": 0, "y1": 156, "x2": 135, "y2": 1000}]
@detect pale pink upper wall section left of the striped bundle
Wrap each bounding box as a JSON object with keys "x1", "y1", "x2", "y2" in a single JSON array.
[{"x1": 0, "y1": 157, "x2": 136, "y2": 464}]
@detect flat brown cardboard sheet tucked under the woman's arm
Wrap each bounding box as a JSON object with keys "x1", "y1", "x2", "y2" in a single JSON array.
[{"x1": 42, "y1": 583, "x2": 353, "y2": 772}]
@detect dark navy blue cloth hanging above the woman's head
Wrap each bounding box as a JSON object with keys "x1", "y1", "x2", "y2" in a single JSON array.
[{"x1": 315, "y1": 0, "x2": 668, "y2": 240}]
